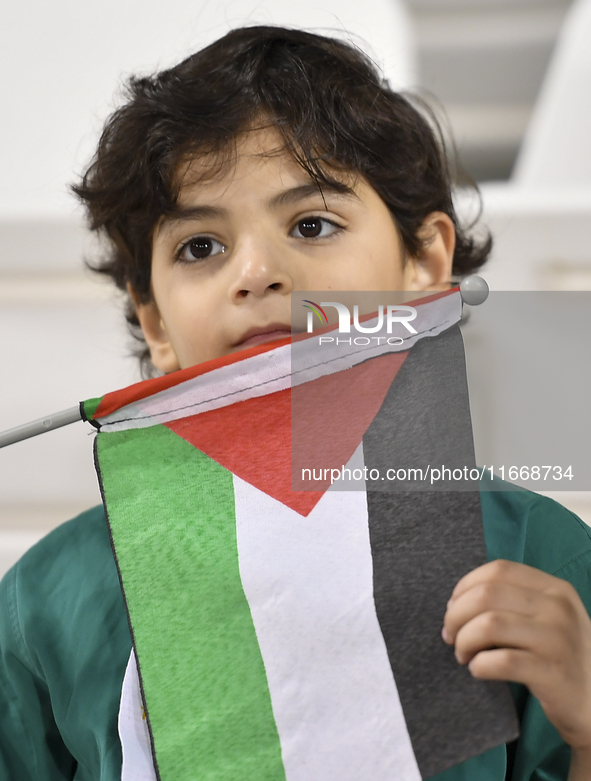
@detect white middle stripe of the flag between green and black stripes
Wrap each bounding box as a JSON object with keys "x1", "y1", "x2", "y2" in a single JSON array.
[{"x1": 234, "y1": 445, "x2": 421, "y2": 781}]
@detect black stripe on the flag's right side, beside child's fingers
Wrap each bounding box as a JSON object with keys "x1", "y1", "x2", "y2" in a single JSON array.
[{"x1": 363, "y1": 326, "x2": 519, "y2": 778}]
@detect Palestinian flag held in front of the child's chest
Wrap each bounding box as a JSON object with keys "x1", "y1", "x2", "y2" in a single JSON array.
[{"x1": 84, "y1": 291, "x2": 517, "y2": 781}]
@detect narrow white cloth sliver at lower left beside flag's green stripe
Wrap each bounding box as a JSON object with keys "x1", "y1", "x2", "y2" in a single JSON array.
[{"x1": 118, "y1": 649, "x2": 156, "y2": 781}]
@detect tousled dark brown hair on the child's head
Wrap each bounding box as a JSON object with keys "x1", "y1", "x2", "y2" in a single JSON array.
[{"x1": 72, "y1": 26, "x2": 492, "y2": 372}]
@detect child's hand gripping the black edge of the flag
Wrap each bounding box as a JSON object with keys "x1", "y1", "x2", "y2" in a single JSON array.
[{"x1": 442, "y1": 559, "x2": 591, "y2": 779}]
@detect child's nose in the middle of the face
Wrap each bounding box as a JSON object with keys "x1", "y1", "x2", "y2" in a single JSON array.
[{"x1": 229, "y1": 242, "x2": 294, "y2": 299}]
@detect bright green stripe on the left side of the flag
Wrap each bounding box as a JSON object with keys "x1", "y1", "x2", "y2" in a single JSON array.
[{"x1": 97, "y1": 426, "x2": 285, "y2": 781}]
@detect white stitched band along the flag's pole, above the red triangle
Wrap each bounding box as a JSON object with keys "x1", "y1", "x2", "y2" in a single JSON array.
[{"x1": 98, "y1": 292, "x2": 462, "y2": 432}]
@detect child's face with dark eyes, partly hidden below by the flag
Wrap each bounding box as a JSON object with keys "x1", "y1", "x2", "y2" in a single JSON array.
[{"x1": 138, "y1": 130, "x2": 454, "y2": 372}]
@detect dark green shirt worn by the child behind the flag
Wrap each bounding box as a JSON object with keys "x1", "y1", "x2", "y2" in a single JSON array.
[{"x1": 0, "y1": 490, "x2": 591, "y2": 781}]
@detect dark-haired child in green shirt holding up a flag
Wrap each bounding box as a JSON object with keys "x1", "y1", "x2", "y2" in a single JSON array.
[{"x1": 0, "y1": 27, "x2": 591, "y2": 781}]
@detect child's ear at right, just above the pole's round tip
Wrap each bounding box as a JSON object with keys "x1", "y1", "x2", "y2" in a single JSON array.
[{"x1": 405, "y1": 212, "x2": 456, "y2": 290}]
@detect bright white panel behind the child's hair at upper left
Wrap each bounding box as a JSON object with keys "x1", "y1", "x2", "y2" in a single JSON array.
[{"x1": 0, "y1": 0, "x2": 412, "y2": 217}]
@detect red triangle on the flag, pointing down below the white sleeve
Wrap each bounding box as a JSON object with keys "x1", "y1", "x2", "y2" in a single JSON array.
[{"x1": 165, "y1": 353, "x2": 407, "y2": 515}]
